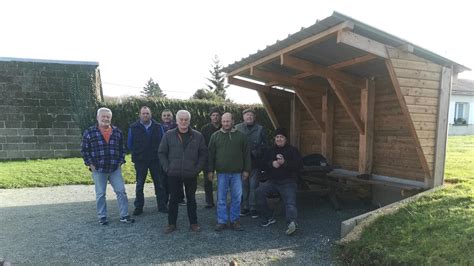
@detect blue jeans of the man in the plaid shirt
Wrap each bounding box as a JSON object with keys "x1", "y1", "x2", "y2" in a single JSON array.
[{"x1": 92, "y1": 167, "x2": 128, "y2": 218}]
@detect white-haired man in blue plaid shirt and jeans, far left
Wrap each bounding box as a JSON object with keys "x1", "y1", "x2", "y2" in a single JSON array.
[{"x1": 81, "y1": 107, "x2": 135, "y2": 225}]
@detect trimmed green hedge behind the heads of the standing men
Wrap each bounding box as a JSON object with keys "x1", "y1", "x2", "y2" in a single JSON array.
[{"x1": 102, "y1": 97, "x2": 273, "y2": 143}]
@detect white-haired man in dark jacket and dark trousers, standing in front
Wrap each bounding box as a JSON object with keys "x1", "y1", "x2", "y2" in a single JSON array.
[{"x1": 158, "y1": 110, "x2": 207, "y2": 234}]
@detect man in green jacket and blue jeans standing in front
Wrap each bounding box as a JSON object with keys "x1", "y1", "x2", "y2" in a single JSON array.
[{"x1": 208, "y1": 113, "x2": 251, "y2": 231}]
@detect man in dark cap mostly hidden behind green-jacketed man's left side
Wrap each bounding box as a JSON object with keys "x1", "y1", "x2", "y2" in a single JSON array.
[{"x1": 201, "y1": 107, "x2": 221, "y2": 209}]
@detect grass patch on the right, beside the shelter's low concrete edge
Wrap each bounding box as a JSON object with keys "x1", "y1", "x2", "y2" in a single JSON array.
[{"x1": 336, "y1": 136, "x2": 474, "y2": 265}]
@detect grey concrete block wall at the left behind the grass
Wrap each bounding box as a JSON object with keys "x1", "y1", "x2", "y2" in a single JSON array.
[{"x1": 0, "y1": 58, "x2": 101, "y2": 160}]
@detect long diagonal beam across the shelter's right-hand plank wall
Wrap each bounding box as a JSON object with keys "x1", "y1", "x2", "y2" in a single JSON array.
[{"x1": 385, "y1": 60, "x2": 431, "y2": 182}]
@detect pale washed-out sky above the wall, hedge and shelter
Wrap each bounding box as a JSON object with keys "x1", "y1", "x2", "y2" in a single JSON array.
[{"x1": 0, "y1": 0, "x2": 474, "y2": 103}]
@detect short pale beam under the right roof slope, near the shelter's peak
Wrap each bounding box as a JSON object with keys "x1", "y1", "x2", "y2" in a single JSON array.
[{"x1": 337, "y1": 30, "x2": 388, "y2": 58}]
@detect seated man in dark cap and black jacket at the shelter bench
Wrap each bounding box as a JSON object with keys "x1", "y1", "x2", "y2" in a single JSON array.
[{"x1": 257, "y1": 128, "x2": 303, "y2": 235}]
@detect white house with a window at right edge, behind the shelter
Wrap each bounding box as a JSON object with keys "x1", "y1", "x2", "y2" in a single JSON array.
[{"x1": 448, "y1": 79, "x2": 474, "y2": 135}]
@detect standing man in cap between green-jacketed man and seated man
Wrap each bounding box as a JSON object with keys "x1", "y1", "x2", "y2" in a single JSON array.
[{"x1": 235, "y1": 109, "x2": 267, "y2": 218}]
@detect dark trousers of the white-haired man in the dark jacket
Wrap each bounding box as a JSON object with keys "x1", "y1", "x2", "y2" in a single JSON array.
[{"x1": 168, "y1": 176, "x2": 197, "y2": 225}]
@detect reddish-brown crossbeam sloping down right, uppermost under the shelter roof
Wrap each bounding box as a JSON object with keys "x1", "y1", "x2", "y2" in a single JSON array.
[{"x1": 280, "y1": 54, "x2": 365, "y2": 88}]
